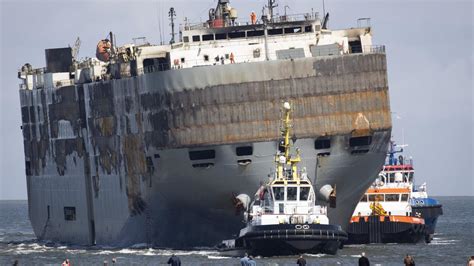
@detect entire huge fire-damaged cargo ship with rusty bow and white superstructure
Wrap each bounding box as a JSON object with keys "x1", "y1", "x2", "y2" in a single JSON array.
[{"x1": 19, "y1": 0, "x2": 391, "y2": 247}]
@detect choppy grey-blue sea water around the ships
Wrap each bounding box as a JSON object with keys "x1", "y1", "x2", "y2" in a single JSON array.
[{"x1": 0, "y1": 197, "x2": 474, "y2": 266}]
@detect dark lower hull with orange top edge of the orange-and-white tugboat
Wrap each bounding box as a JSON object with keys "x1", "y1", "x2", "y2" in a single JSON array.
[{"x1": 345, "y1": 216, "x2": 426, "y2": 244}]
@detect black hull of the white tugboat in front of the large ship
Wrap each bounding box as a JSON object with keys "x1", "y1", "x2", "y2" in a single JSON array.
[{"x1": 236, "y1": 224, "x2": 347, "y2": 256}]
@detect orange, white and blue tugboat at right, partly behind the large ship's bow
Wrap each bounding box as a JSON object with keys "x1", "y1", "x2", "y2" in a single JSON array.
[{"x1": 347, "y1": 142, "x2": 434, "y2": 244}]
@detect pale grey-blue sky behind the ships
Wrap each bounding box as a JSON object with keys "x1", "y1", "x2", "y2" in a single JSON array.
[{"x1": 0, "y1": 0, "x2": 474, "y2": 199}]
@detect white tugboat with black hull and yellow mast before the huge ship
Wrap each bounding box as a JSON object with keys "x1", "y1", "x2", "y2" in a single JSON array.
[{"x1": 222, "y1": 102, "x2": 347, "y2": 256}]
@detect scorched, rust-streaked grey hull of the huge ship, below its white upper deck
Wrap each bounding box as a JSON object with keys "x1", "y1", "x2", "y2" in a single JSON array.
[{"x1": 20, "y1": 54, "x2": 391, "y2": 247}]
